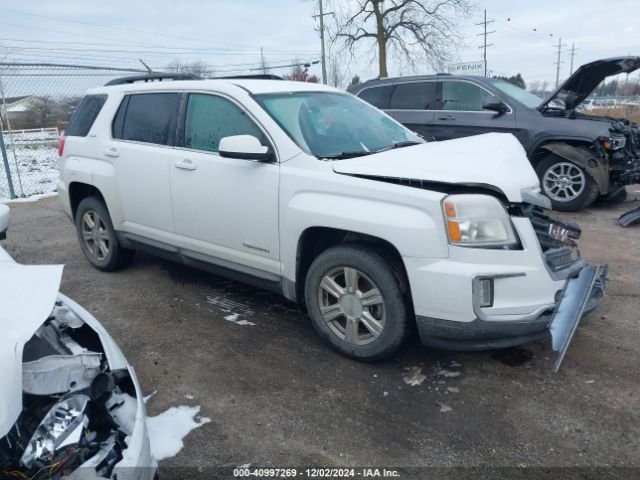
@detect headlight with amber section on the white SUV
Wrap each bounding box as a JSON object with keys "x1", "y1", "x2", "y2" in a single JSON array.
[{"x1": 442, "y1": 195, "x2": 518, "y2": 248}]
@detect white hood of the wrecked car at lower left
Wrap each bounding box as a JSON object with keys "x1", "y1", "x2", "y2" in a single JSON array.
[{"x1": 0, "y1": 262, "x2": 62, "y2": 438}]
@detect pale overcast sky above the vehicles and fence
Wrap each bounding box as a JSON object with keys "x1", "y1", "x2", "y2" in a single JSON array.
[{"x1": 0, "y1": 0, "x2": 640, "y2": 88}]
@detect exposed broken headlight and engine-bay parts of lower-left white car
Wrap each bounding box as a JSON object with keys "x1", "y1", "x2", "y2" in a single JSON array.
[{"x1": 0, "y1": 302, "x2": 137, "y2": 480}]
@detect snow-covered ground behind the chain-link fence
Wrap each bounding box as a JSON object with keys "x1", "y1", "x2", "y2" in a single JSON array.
[{"x1": 0, "y1": 143, "x2": 59, "y2": 199}]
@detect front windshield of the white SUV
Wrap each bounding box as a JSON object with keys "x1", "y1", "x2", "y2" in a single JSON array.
[{"x1": 256, "y1": 92, "x2": 424, "y2": 158}]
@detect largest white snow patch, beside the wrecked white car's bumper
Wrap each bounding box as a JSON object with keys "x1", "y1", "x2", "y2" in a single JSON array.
[{"x1": 147, "y1": 405, "x2": 211, "y2": 460}]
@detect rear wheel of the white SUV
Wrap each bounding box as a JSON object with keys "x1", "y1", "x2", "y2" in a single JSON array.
[{"x1": 76, "y1": 197, "x2": 135, "y2": 272}]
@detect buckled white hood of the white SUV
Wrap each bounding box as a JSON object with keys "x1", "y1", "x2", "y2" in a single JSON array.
[{"x1": 333, "y1": 133, "x2": 539, "y2": 202}]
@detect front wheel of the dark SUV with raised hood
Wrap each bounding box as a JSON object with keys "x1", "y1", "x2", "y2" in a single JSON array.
[{"x1": 536, "y1": 155, "x2": 598, "y2": 212}]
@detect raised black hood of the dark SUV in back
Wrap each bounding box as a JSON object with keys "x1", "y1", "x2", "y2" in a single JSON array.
[{"x1": 538, "y1": 57, "x2": 640, "y2": 111}]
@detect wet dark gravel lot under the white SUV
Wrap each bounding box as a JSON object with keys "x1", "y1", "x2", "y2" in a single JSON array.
[{"x1": 3, "y1": 187, "x2": 640, "y2": 478}]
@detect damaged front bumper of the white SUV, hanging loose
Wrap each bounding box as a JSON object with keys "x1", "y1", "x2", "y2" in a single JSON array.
[{"x1": 412, "y1": 209, "x2": 607, "y2": 370}]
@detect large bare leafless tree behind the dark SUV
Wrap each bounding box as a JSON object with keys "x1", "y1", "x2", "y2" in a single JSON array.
[{"x1": 331, "y1": 0, "x2": 475, "y2": 77}]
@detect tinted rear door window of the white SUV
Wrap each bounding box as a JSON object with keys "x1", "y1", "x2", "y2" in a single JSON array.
[{"x1": 112, "y1": 93, "x2": 180, "y2": 146}]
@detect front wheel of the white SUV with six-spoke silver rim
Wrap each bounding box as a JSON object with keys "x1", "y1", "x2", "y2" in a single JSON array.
[{"x1": 305, "y1": 244, "x2": 411, "y2": 361}]
